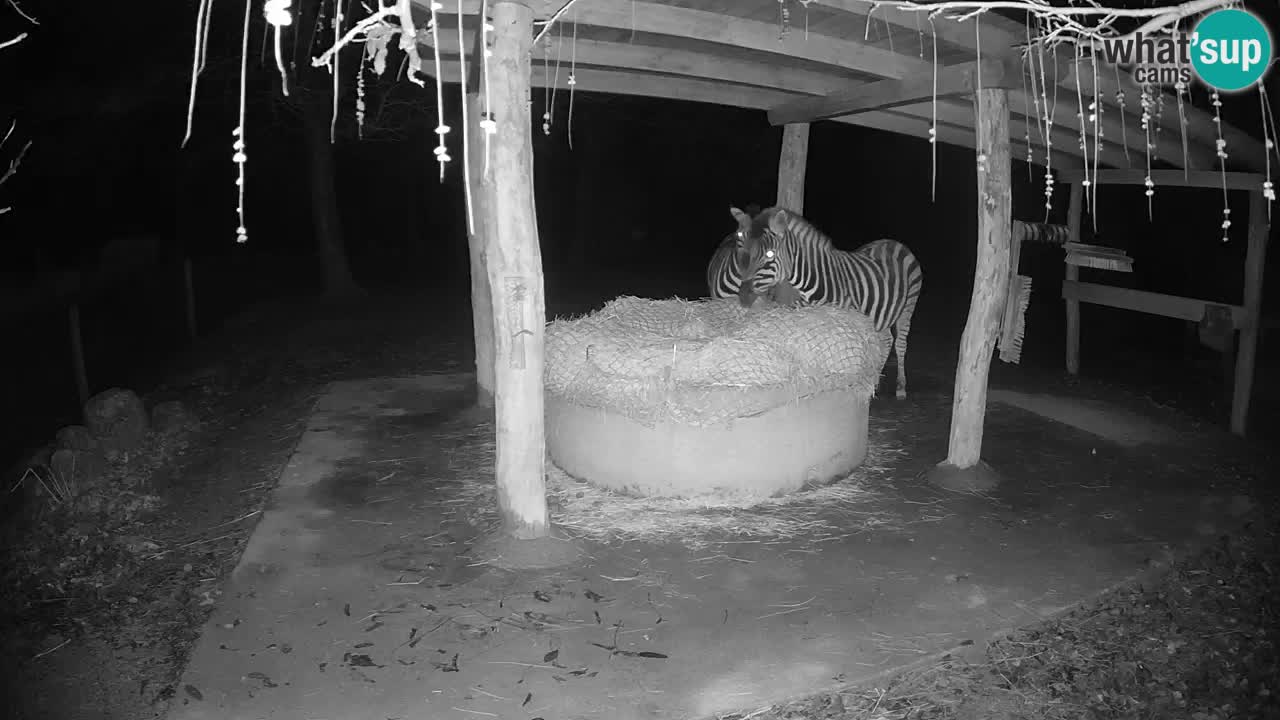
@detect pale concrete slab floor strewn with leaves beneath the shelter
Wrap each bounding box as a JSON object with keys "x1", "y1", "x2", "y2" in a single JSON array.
[{"x1": 169, "y1": 375, "x2": 1242, "y2": 720}]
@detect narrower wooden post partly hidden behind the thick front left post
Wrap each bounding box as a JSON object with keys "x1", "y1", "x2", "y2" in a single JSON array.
[{"x1": 467, "y1": 89, "x2": 495, "y2": 397}]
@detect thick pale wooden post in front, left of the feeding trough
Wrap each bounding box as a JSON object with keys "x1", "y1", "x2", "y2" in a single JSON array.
[{"x1": 472, "y1": 0, "x2": 550, "y2": 539}]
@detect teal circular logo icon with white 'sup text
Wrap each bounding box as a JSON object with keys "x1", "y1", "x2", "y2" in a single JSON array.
[{"x1": 1192, "y1": 8, "x2": 1271, "y2": 91}]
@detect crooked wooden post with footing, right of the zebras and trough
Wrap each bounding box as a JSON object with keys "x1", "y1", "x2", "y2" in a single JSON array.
[{"x1": 931, "y1": 83, "x2": 1012, "y2": 489}]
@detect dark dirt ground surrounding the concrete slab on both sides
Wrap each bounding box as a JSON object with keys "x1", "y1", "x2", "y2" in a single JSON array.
[{"x1": 3, "y1": 289, "x2": 1280, "y2": 720}]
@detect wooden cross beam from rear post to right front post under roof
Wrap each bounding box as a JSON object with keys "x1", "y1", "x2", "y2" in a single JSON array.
[{"x1": 769, "y1": 58, "x2": 1023, "y2": 126}]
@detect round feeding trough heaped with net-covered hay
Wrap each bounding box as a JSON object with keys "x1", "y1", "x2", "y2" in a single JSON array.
[{"x1": 545, "y1": 297, "x2": 890, "y2": 497}]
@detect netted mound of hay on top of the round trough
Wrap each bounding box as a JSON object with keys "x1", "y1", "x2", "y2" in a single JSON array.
[{"x1": 545, "y1": 297, "x2": 891, "y2": 427}]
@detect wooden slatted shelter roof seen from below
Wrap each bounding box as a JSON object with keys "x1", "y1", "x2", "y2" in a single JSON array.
[{"x1": 413, "y1": 0, "x2": 1265, "y2": 170}]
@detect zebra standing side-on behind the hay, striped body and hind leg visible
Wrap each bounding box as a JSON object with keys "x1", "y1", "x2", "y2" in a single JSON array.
[{"x1": 735, "y1": 208, "x2": 924, "y2": 400}]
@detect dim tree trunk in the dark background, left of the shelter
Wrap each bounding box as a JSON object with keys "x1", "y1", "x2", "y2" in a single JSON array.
[{"x1": 302, "y1": 101, "x2": 360, "y2": 297}]
